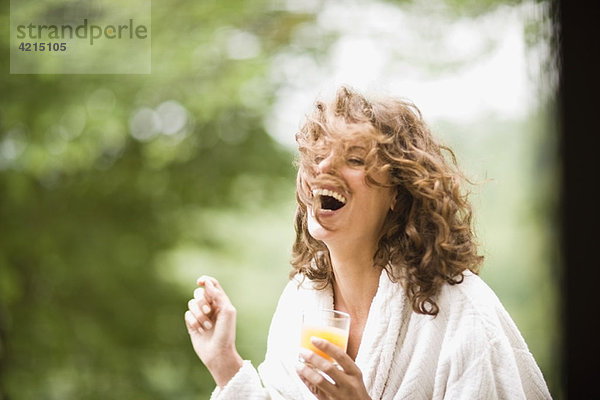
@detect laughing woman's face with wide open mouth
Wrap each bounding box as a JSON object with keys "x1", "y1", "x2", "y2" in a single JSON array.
[{"x1": 308, "y1": 140, "x2": 395, "y2": 247}]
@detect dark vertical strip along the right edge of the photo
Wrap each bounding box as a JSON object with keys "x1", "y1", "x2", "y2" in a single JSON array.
[{"x1": 557, "y1": 0, "x2": 600, "y2": 399}]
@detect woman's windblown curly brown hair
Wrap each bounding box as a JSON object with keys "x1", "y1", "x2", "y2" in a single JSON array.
[{"x1": 290, "y1": 87, "x2": 483, "y2": 315}]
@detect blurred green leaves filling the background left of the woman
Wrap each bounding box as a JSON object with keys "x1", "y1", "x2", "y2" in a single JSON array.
[{"x1": 0, "y1": 1, "x2": 304, "y2": 399}]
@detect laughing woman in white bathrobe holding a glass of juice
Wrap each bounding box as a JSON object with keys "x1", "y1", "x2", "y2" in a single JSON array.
[{"x1": 185, "y1": 88, "x2": 550, "y2": 399}]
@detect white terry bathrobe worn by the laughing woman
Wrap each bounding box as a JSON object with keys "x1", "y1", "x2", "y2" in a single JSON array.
[{"x1": 211, "y1": 272, "x2": 551, "y2": 400}]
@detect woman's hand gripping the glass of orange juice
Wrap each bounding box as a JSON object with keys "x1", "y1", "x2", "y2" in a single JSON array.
[{"x1": 296, "y1": 337, "x2": 371, "y2": 400}]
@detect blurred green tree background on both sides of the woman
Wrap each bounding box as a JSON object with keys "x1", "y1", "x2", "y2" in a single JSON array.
[{"x1": 0, "y1": 0, "x2": 561, "y2": 399}]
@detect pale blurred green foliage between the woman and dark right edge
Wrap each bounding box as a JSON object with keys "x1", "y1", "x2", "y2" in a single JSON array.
[{"x1": 436, "y1": 101, "x2": 563, "y2": 399}]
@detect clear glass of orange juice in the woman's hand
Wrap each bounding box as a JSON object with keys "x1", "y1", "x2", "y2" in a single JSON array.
[{"x1": 300, "y1": 309, "x2": 350, "y2": 361}]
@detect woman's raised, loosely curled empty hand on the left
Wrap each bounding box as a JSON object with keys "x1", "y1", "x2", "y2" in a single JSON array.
[{"x1": 185, "y1": 276, "x2": 243, "y2": 387}]
